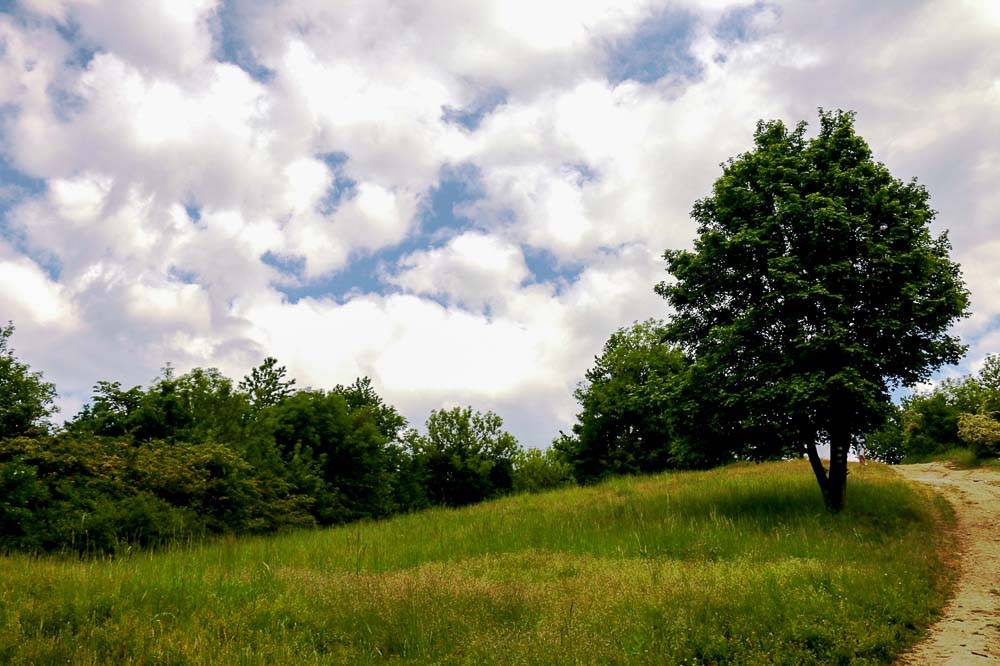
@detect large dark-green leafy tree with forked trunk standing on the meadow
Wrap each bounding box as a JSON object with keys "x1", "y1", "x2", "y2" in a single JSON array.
[{"x1": 657, "y1": 110, "x2": 968, "y2": 511}]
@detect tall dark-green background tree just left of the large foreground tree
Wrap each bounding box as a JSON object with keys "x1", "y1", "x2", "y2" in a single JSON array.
[{"x1": 554, "y1": 320, "x2": 687, "y2": 482}]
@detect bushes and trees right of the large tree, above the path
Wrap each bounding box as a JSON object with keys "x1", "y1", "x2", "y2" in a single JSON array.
[{"x1": 863, "y1": 354, "x2": 1000, "y2": 463}]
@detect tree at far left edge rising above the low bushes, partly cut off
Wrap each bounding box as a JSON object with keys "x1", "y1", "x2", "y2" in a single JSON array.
[{"x1": 0, "y1": 322, "x2": 57, "y2": 439}]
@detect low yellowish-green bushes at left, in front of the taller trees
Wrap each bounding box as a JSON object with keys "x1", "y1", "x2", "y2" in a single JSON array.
[{"x1": 0, "y1": 436, "x2": 312, "y2": 553}]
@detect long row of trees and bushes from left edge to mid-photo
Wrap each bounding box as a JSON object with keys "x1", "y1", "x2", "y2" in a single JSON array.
[{"x1": 0, "y1": 325, "x2": 572, "y2": 553}]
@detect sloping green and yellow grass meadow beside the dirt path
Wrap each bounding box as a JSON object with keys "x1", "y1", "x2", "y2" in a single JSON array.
[{"x1": 0, "y1": 462, "x2": 953, "y2": 664}]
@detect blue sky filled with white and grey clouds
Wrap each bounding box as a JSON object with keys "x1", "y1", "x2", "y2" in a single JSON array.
[{"x1": 0, "y1": 0, "x2": 1000, "y2": 447}]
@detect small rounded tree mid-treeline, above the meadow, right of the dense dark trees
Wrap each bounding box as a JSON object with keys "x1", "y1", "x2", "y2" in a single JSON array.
[{"x1": 407, "y1": 407, "x2": 518, "y2": 506}]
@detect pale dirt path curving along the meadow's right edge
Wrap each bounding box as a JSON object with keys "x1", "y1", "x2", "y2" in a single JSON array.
[{"x1": 895, "y1": 463, "x2": 1000, "y2": 666}]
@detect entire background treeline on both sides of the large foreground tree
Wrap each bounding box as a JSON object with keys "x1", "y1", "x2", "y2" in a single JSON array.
[{"x1": 0, "y1": 312, "x2": 1000, "y2": 552}]
